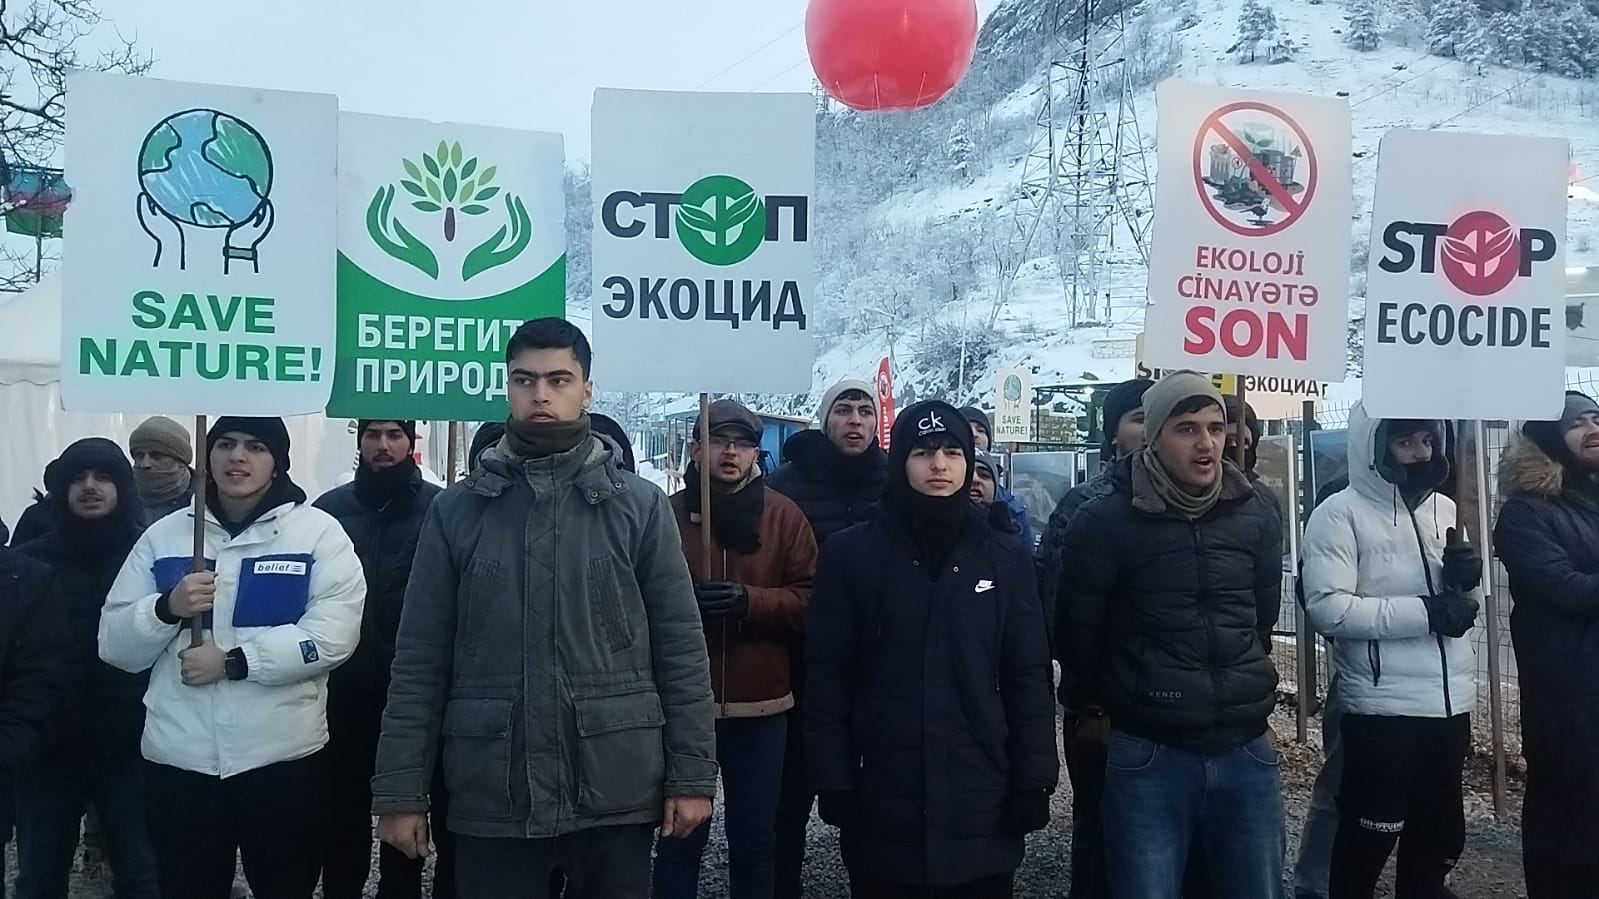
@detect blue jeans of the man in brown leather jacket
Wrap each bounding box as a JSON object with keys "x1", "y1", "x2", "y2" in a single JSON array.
[{"x1": 654, "y1": 715, "x2": 788, "y2": 899}]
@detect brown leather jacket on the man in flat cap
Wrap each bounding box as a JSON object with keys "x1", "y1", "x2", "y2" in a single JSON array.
[{"x1": 672, "y1": 485, "x2": 817, "y2": 718}]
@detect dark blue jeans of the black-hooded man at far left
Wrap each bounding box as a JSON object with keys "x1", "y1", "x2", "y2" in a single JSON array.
[{"x1": 16, "y1": 753, "x2": 158, "y2": 899}]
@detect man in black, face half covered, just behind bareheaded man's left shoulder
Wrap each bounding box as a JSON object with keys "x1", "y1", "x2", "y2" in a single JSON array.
[{"x1": 315, "y1": 419, "x2": 454, "y2": 899}]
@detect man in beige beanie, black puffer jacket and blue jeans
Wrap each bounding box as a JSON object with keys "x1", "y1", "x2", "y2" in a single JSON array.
[{"x1": 1055, "y1": 371, "x2": 1286, "y2": 899}]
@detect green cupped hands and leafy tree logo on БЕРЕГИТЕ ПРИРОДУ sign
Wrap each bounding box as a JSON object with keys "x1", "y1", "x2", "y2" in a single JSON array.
[{"x1": 366, "y1": 141, "x2": 532, "y2": 282}]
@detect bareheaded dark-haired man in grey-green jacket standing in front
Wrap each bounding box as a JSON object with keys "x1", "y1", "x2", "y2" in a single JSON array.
[{"x1": 373, "y1": 318, "x2": 716, "y2": 899}]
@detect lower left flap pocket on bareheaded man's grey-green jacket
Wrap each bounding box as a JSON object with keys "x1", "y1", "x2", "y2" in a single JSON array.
[{"x1": 443, "y1": 699, "x2": 515, "y2": 821}]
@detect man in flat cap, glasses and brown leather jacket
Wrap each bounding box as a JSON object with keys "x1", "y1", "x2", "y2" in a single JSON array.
[{"x1": 656, "y1": 400, "x2": 815, "y2": 899}]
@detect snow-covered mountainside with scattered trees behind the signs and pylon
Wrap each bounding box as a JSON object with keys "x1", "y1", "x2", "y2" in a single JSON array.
[{"x1": 588, "y1": 0, "x2": 1599, "y2": 414}]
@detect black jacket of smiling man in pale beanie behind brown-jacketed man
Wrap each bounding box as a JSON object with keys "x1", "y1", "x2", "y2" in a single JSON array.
[{"x1": 766, "y1": 430, "x2": 889, "y2": 545}]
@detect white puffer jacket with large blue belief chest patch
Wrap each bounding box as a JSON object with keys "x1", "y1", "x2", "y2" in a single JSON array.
[{"x1": 99, "y1": 502, "x2": 366, "y2": 777}]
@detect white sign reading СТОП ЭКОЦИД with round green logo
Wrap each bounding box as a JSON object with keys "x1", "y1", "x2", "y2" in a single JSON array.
[{"x1": 592, "y1": 90, "x2": 815, "y2": 394}]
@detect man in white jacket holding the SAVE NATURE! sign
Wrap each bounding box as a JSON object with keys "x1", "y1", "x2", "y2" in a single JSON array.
[{"x1": 99, "y1": 418, "x2": 366, "y2": 899}]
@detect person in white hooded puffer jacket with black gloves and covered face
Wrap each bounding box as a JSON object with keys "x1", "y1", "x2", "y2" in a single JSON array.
[{"x1": 1303, "y1": 403, "x2": 1482, "y2": 899}]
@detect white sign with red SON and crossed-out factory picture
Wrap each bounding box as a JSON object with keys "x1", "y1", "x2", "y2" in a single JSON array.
[{"x1": 1145, "y1": 78, "x2": 1353, "y2": 381}]
